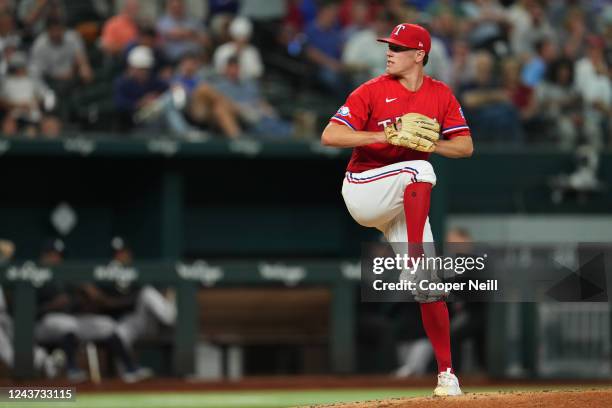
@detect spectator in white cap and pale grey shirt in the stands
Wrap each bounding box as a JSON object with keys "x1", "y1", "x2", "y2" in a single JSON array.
[{"x1": 213, "y1": 17, "x2": 264, "y2": 80}]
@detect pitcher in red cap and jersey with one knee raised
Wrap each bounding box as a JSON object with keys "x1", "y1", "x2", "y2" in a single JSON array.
[{"x1": 321, "y1": 23, "x2": 473, "y2": 396}]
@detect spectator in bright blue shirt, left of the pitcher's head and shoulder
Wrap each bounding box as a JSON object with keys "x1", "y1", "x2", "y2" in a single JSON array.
[{"x1": 305, "y1": 2, "x2": 350, "y2": 98}]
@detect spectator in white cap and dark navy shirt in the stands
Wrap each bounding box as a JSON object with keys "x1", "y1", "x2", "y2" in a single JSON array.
[{"x1": 114, "y1": 45, "x2": 168, "y2": 130}]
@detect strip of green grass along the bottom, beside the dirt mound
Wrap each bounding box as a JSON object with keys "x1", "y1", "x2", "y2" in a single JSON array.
[{"x1": 0, "y1": 386, "x2": 608, "y2": 408}]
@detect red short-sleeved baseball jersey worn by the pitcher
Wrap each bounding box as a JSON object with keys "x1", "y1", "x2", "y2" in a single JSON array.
[{"x1": 330, "y1": 74, "x2": 470, "y2": 173}]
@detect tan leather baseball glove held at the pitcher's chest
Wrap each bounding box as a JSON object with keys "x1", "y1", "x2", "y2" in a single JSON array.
[{"x1": 385, "y1": 112, "x2": 440, "y2": 153}]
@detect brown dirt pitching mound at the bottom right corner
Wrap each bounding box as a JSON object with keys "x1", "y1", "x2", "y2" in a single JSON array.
[{"x1": 308, "y1": 389, "x2": 612, "y2": 408}]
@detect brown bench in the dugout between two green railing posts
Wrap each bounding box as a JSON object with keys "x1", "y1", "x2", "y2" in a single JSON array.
[{"x1": 198, "y1": 286, "x2": 332, "y2": 379}]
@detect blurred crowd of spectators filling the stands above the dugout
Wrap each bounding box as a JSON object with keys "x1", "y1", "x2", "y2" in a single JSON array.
[{"x1": 0, "y1": 0, "x2": 612, "y2": 149}]
